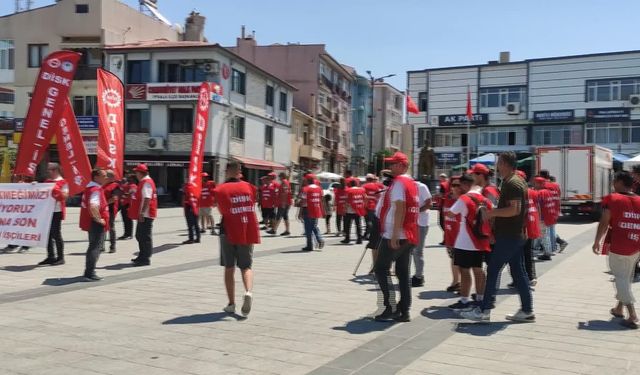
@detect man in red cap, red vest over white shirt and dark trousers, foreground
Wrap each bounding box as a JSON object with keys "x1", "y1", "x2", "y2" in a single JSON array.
[{"x1": 374, "y1": 152, "x2": 419, "y2": 322}]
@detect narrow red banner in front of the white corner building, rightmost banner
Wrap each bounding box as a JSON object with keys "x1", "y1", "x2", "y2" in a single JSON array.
[{"x1": 189, "y1": 82, "x2": 211, "y2": 198}]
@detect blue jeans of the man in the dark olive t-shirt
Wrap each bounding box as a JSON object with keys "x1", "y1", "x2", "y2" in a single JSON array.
[{"x1": 480, "y1": 238, "x2": 533, "y2": 313}]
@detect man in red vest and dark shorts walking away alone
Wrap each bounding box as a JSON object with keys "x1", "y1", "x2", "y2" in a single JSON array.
[{"x1": 215, "y1": 161, "x2": 260, "y2": 316}]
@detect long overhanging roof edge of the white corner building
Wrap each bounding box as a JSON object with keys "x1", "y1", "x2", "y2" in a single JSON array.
[{"x1": 104, "y1": 39, "x2": 298, "y2": 91}]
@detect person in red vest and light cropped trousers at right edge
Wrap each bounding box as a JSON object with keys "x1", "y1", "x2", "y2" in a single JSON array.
[{"x1": 593, "y1": 171, "x2": 640, "y2": 329}]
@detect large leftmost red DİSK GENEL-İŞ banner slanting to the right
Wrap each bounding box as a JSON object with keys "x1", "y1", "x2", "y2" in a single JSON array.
[{"x1": 14, "y1": 51, "x2": 80, "y2": 176}]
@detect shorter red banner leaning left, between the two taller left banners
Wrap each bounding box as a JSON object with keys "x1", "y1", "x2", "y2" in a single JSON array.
[{"x1": 56, "y1": 98, "x2": 91, "y2": 196}]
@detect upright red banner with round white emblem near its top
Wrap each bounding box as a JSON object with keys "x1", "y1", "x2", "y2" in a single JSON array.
[{"x1": 96, "y1": 68, "x2": 124, "y2": 179}]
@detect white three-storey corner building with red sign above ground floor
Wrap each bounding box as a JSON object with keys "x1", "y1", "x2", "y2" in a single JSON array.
[{"x1": 106, "y1": 40, "x2": 295, "y2": 199}]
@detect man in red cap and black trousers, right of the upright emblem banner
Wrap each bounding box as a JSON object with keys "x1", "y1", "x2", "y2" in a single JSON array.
[{"x1": 131, "y1": 164, "x2": 158, "y2": 267}]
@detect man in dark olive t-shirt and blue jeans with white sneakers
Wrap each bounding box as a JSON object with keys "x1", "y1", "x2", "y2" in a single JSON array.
[{"x1": 461, "y1": 151, "x2": 536, "y2": 322}]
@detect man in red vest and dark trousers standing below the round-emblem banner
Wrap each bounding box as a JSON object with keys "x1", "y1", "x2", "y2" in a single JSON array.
[{"x1": 80, "y1": 169, "x2": 109, "y2": 281}]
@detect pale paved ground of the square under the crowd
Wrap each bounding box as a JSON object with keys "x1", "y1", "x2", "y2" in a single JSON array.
[{"x1": 0, "y1": 209, "x2": 640, "y2": 375}]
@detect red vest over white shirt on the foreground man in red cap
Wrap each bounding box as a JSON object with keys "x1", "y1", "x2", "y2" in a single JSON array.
[{"x1": 380, "y1": 176, "x2": 420, "y2": 245}]
